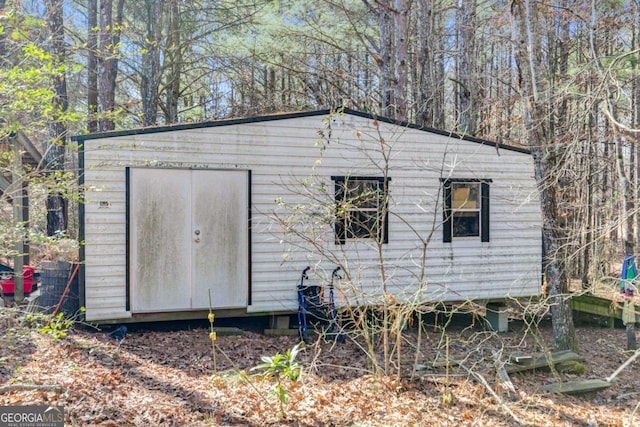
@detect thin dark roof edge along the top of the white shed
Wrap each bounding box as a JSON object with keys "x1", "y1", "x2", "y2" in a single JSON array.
[{"x1": 71, "y1": 108, "x2": 531, "y2": 154}]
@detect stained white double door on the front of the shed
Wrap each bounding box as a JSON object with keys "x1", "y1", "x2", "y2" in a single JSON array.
[{"x1": 129, "y1": 168, "x2": 249, "y2": 313}]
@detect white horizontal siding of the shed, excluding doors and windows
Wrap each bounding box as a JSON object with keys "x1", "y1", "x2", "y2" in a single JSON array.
[{"x1": 79, "y1": 116, "x2": 541, "y2": 320}]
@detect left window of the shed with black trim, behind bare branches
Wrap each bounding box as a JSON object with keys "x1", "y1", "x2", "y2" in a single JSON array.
[{"x1": 331, "y1": 176, "x2": 390, "y2": 244}]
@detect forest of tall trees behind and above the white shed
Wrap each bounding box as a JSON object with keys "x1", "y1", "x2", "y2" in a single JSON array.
[{"x1": 0, "y1": 0, "x2": 640, "y2": 308}]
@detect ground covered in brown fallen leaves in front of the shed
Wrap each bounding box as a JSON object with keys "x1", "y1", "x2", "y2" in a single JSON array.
[{"x1": 0, "y1": 309, "x2": 640, "y2": 427}]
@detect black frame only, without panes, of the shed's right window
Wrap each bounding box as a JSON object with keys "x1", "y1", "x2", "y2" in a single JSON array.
[{"x1": 441, "y1": 178, "x2": 492, "y2": 243}]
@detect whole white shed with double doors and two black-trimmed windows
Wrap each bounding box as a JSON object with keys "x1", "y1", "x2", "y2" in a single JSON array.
[{"x1": 74, "y1": 110, "x2": 542, "y2": 323}]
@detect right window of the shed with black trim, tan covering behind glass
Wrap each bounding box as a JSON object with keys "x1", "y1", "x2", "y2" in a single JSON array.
[{"x1": 442, "y1": 178, "x2": 491, "y2": 242}]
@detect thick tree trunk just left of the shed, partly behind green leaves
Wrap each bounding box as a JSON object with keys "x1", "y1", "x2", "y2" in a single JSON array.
[{"x1": 45, "y1": 0, "x2": 69, "y2": 236}]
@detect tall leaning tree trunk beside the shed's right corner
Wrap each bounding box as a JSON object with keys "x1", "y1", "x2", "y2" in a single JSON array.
[{"x1": 511, "y1": 0, "x2": 577, "y2": 351}]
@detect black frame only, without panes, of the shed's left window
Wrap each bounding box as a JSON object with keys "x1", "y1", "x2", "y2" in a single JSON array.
[{"x1": 331, "y1": 176, "x2": 391, "y2": 245}]
